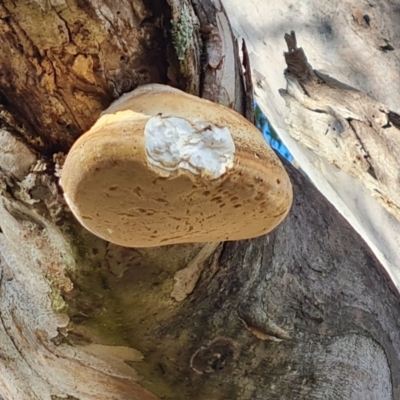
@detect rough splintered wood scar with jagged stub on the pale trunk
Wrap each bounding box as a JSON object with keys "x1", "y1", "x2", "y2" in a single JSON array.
[{"x1": 281, "y1": 32, "x2": 400, "y2": 220}]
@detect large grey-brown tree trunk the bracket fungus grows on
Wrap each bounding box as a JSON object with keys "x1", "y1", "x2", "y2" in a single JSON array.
[{"x1": 0, "y1": 0, "x2": 400, "y2": 400}]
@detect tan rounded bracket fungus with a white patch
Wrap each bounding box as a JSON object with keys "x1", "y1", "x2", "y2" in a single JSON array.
[{"x1": 61, "y1": 84, "x2": 292, "y2": 247}]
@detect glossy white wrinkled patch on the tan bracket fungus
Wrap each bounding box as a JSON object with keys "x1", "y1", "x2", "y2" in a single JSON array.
[{"x1": 144, "y1": 115, "x2": 235, "y2": 179}]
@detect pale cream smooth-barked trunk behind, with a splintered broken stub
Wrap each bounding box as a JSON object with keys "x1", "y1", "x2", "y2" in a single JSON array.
[{"x1": 224, "y1": 0, "x2": 400, "y2": 290}]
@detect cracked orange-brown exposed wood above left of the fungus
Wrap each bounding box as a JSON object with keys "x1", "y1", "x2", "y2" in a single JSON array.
[{"x1": 0, "y1": 0, "x2": 168, "y2": 153}]
